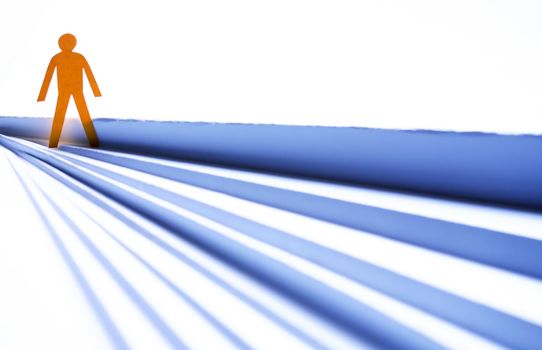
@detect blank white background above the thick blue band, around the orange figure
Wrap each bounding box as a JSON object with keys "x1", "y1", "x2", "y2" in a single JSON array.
[{"x1": 0, "y1": 0, "x2": 542, "y2": 133}]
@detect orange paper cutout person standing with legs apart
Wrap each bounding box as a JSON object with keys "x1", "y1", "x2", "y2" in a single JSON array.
[{"x1": 38, "y1": 34, "x2": 102, "y2": 148}]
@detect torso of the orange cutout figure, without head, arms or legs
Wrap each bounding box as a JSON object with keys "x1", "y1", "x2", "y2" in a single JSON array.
[{"x1": 54, "y1": 51, "x2": 85, "y2": 93}]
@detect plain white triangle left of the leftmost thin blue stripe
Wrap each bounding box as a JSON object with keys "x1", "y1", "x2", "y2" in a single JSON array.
[{"x1": 0, "y1": 148, "x2": 111, "y2": 350}]
